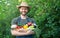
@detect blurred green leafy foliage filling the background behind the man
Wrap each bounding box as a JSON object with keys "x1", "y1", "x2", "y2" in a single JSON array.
[{"x1": 0, "y1": 0, "x2": 60, "y2": 38}]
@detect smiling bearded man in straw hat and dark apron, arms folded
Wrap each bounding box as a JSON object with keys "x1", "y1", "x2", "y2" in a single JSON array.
[{"x1": 11, "y1": 2, "x2": 36, "y2": 38}]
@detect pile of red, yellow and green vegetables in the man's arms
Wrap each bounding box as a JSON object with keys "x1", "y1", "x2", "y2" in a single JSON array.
[{"x1": 11, "y1": 22, "x2": 36, "y2": 31}]
